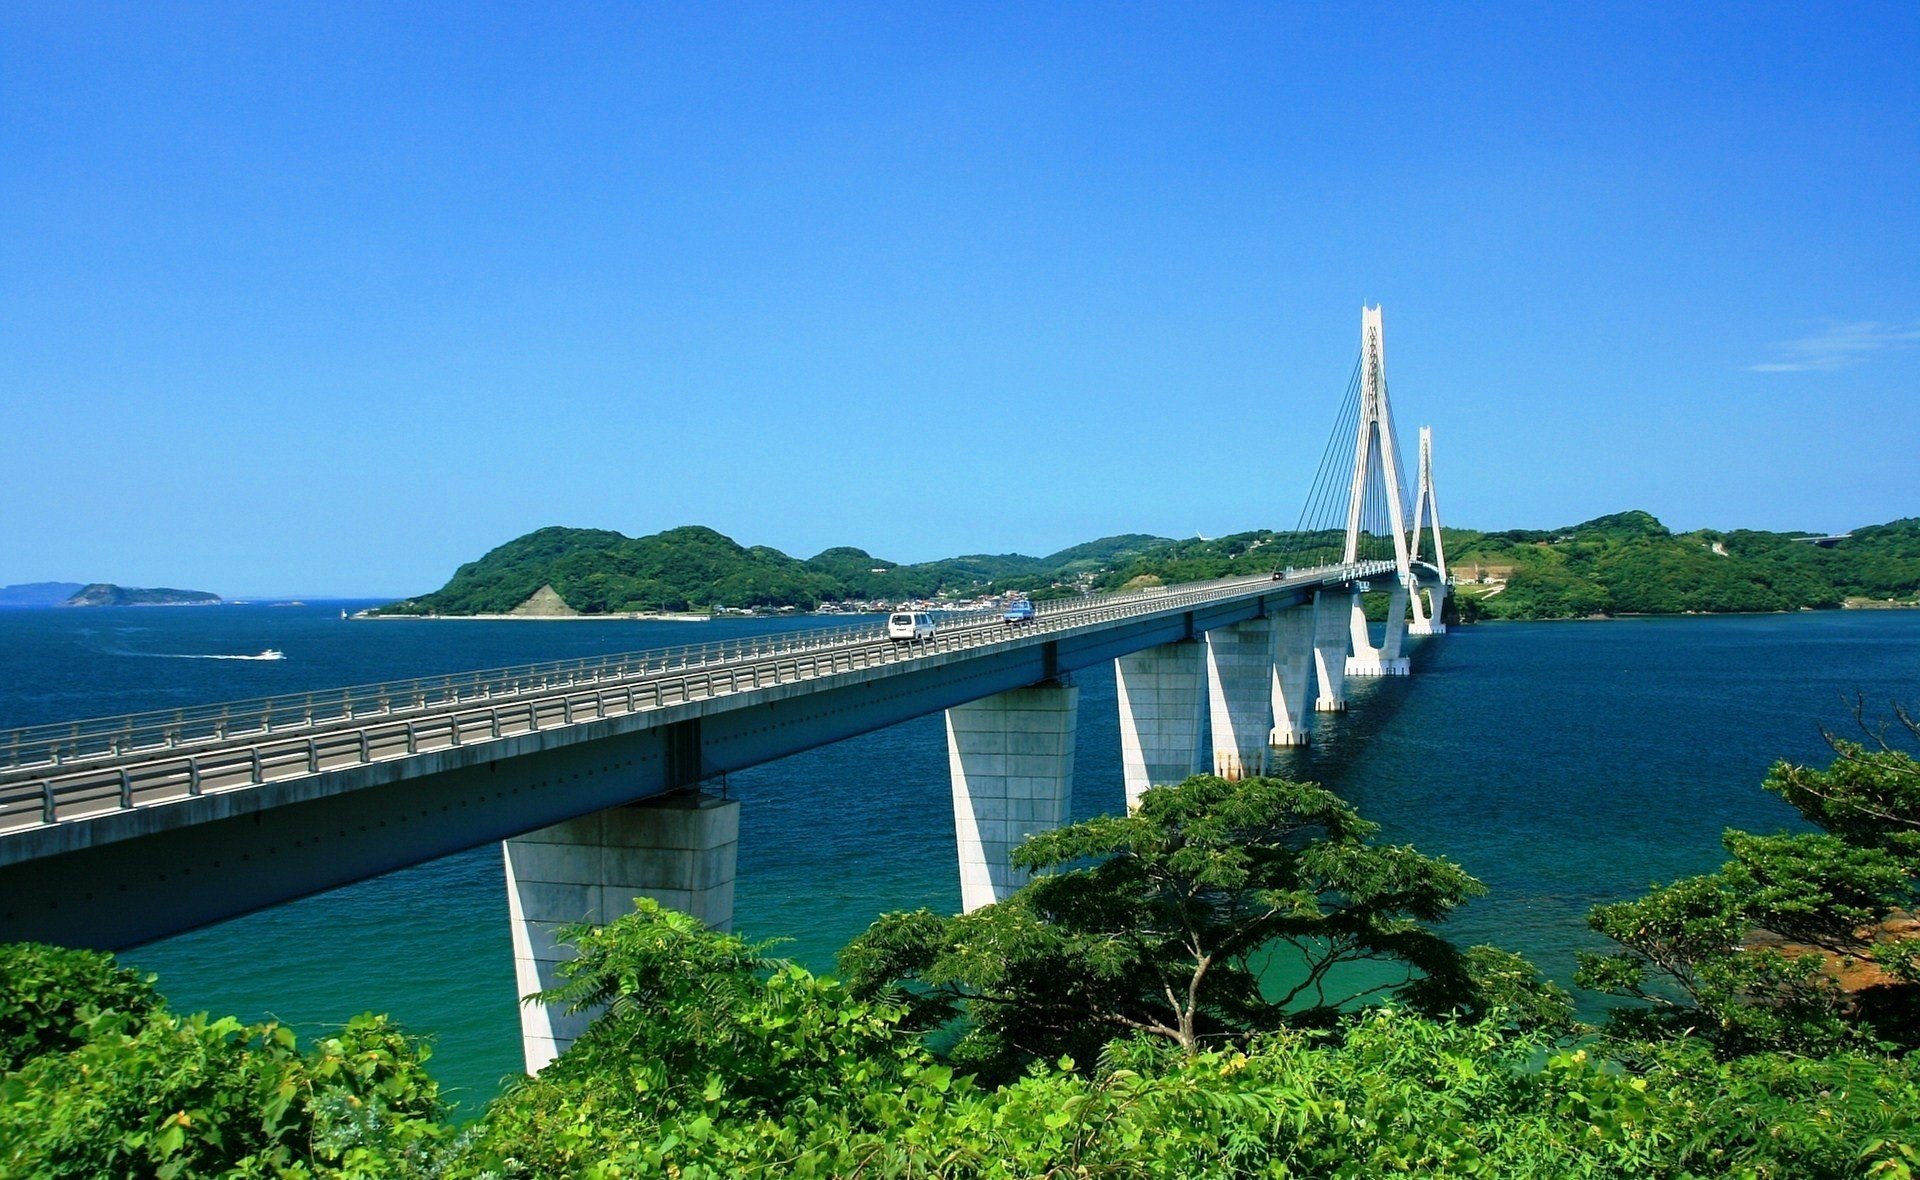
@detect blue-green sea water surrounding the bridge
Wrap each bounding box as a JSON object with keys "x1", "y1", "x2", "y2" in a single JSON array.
[{"x1": 0, "y1": 602, "x2": 1920, "y2": 1109}]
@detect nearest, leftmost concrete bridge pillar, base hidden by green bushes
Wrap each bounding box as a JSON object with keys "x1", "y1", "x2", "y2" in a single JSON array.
[{"x1": 501, "y1": 791, "x2": 739, "y2": 1073}]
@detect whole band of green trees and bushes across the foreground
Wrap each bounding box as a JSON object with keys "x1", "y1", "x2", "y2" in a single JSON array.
[{"x1": 0, "y1": 714, "x2": 1920, "y2": 1180}]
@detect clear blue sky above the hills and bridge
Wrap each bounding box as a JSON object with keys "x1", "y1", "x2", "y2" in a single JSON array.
[{"x1": 0, "y1": 0, "x2": 1920, "y2": 595}]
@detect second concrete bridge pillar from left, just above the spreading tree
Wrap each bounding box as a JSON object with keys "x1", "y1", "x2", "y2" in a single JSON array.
[{"x1": 947, "y1": 681, "x2": 1079, "y2": 913}]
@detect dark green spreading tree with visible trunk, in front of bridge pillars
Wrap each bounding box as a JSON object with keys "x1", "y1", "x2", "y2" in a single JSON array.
[{"x1": 841, "y1": 775, "x2": 1553, "y2": 1076}]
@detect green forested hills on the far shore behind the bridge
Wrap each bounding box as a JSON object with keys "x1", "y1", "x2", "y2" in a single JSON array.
[{"x1": 369, "y1": 510, "x2": 1920, "y2": 620}]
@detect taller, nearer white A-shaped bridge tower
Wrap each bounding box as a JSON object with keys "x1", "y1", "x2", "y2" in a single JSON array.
[{"x1": 1344, "y1": 305, "x2": 1415, "y2": 675}]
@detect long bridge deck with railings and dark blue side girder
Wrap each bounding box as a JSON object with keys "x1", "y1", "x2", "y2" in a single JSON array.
[{"x1": 0, "y1": 562, "x2": 1394, "y2": 950}]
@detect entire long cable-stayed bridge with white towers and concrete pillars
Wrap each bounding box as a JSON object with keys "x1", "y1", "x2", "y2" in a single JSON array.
[{"x1": 0, "y1": 307, "x2": 1448, "y2": 1071}]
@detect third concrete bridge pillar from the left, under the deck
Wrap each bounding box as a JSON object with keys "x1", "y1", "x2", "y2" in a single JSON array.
[{"x1": 1114, "y1": 639, "x2": 1206, "y2": 812}]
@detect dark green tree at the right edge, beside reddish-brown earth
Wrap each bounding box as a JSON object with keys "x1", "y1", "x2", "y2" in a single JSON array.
[{"x1": 1576, "y1": 710, "x2": 1920, "y2": 1053}]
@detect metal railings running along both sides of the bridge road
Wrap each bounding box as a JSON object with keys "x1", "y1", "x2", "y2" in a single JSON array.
[{"x1": 0, "y1": 562, "x2": 1377, "y2": 813}]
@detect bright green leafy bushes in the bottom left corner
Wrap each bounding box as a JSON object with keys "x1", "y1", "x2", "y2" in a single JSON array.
[{"x1": 0, "y1": 944, "x2": 447, "y2": 1180}]
